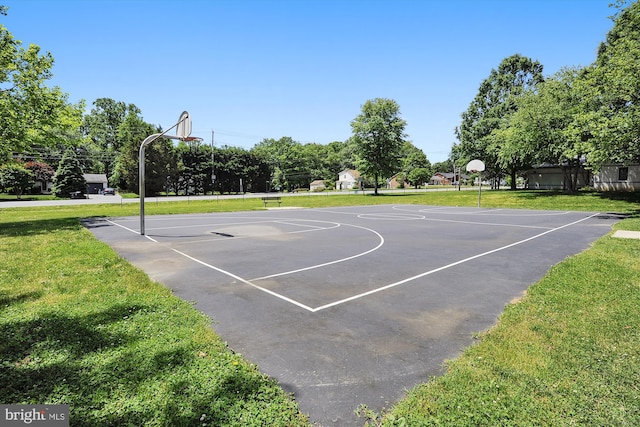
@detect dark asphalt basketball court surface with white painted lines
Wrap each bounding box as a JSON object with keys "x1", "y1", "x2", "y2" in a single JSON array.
[{"x1": 85, "y1": 205, "x2": 620, "y2": 426}]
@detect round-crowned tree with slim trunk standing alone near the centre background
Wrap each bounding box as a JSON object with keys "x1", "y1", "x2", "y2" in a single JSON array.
[{"x1": 351, "y1": 98, "x2": 407, "y2": 195}]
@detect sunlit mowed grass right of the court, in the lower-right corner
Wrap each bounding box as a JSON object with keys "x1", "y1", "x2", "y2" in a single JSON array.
[{"x1": 382, "y1": 219, "x2": 640, "y2": 426}]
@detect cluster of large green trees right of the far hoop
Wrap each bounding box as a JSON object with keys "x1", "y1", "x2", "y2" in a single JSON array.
[{"x1": 451, "y1": 1, "x2": 640, "y2": 190}]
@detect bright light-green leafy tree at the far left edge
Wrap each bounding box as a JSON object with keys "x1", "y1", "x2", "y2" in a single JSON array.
[{"x1": 0, "y1": 15, "x2": 84, "y2": 160}]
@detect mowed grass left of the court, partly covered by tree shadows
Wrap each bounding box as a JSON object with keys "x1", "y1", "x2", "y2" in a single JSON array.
[{"x1": 0, "y1": 206, "x2": 308, "y2": 426}]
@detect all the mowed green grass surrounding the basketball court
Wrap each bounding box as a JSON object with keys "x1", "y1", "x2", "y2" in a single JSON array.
[{"x1": 0, "y1": 191, "x2": 640, "y2": 426}]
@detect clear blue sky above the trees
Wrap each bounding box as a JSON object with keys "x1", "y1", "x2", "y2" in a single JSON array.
[{"x1": 0, "y1": 0, "x2": 615, "y2": 162}]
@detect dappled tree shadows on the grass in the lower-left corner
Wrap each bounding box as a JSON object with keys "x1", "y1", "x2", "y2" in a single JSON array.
[{"x1": 0, "y1": 302, "x2": 293, "y2": 426}]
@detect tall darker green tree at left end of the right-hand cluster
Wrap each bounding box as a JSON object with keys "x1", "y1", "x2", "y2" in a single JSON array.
[{"x1": 454, "y1": 54, "x2": 543, "y2": 188}]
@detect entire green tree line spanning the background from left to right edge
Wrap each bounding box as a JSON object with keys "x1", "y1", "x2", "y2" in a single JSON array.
[{"x1": 0, "y1": 0, "x2": 640, "y2": 195}]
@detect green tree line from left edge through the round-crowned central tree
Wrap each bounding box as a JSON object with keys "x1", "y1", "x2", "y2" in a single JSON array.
[{"x1": 0, "y1": 3, "x2": 431, "y2": 197}]
